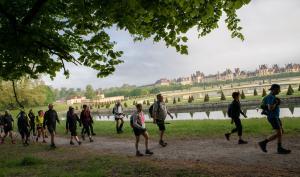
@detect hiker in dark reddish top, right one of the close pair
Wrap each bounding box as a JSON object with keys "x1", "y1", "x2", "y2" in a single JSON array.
[{"x1": 80, "y1": 105, "x2": 94, "y2": 142}]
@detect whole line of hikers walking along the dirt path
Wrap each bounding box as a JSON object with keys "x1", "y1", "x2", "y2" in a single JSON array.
[{"x1": 0, "y1": 84, "x2": 291, "y2": 156}]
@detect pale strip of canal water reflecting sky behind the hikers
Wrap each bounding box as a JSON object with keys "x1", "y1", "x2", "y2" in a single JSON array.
[{"x1": 60, "y1": 107, "x2": 300, "y2": 121}]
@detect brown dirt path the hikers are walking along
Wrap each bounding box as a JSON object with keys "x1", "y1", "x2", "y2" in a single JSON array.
[{"x1": 57, "y1": 136, "x2": 300, "y2": 177}]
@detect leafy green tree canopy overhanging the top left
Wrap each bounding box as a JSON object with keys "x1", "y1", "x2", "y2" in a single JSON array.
[{"x1": 0, "y1": 0, "x2": 250, "y2": 80}]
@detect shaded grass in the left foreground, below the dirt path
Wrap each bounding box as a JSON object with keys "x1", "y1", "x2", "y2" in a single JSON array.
[{"x1": 0, "y1": 144, "x2": 204, "y2": 177}]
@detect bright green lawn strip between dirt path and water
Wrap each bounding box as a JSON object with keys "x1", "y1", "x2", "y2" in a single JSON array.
[{"x1": 58, "y1": 118, "x2": 300, "y2": 139}]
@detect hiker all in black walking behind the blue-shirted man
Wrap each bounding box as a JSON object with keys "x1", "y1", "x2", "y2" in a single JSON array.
[{"x1": 225, "y1": 92, "x2": 248, "y2": 144}]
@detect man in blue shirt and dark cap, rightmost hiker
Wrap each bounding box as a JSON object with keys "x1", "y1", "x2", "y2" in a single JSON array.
[{"x1": 258, "y1": 84, "x2": 291, "y2": 154}]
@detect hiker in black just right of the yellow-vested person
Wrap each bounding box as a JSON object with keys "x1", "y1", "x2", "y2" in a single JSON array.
[{"x1": 43, "y1": 104, "x2": 60, "y2": 148}]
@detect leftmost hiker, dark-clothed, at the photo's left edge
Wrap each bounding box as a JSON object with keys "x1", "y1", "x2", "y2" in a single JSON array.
[{"x1": 0, "y1": 110, "x2": 16, "y2": 144}]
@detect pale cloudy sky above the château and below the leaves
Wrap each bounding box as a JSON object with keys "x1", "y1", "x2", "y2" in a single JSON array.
[{"x1": 42, "y1": 0, "x2": 300, "y2": 88}]
